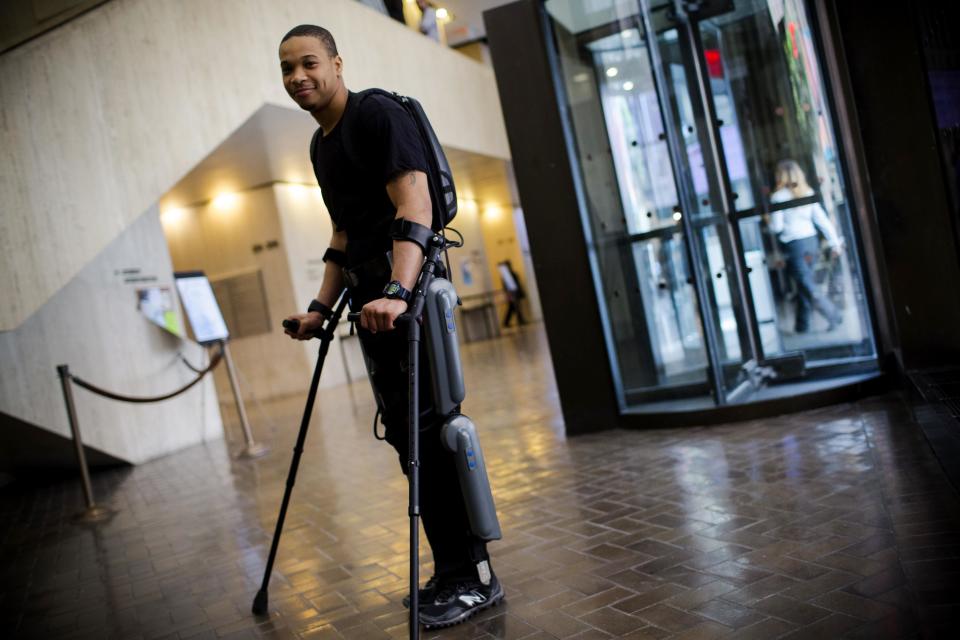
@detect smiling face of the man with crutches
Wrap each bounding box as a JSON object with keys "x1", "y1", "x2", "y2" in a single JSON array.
[{"x1": 280, "y1": 36, "x2": 343, "y2": 113}]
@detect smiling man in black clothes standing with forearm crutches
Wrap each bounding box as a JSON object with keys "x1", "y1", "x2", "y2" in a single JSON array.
[{"x1": 280, "y1": 25, "x2": 503, "y2": 628}]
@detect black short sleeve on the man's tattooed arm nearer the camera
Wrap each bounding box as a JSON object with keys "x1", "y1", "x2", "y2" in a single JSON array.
[{"x1": 360, "y1": 95, "x2": 428, "y2": 184}]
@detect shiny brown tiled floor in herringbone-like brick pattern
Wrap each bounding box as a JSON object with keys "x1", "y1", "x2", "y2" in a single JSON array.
[{"x1": 0, "y1": 328, "x2": 960, "y2": 640}]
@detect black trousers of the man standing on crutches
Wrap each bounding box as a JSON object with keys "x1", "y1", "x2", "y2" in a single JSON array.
[{"x1": 358, "y1": 302, "x2": 489, "y2": 579}]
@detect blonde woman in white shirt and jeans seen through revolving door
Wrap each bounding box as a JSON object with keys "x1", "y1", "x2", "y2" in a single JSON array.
[{"x1": 768, "y1": 160, "x2": 843, "y2": 333}]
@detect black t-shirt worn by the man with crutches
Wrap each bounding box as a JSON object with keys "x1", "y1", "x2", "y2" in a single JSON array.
[{"x1": 315, "y1": 92, "x2": 427, "y2": 266}]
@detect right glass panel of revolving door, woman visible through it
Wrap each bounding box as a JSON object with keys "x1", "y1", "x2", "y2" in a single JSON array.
[{"x1": 696, "y1": 0, "x2": 875, "y2": 364}]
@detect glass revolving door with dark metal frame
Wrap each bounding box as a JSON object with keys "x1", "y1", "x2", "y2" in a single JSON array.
[{"x1": 542, "y1": 0, "x2": 877, "y2": 412}]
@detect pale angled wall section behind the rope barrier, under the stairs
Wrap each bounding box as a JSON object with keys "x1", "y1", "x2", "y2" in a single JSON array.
[{"x1": 0, "y1": 207, "x2": 223, "y2": 463}]
